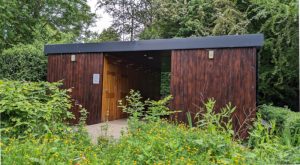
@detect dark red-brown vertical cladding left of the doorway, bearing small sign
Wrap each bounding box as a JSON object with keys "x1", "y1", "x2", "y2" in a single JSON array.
[{"x1": 47, "y1": 53, "x2": 103, "y2": 124}]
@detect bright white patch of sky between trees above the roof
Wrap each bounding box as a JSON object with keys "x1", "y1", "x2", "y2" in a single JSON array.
[{"x1": 87, "y1": 0, "x2": 112, "y2": 33}]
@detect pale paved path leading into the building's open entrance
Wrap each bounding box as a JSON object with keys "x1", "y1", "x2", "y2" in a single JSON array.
[{"x1": 86, "y1": 119, "x2": 127, "y2": 143}]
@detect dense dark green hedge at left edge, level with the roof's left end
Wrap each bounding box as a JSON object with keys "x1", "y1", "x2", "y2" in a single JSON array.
[{"x1": 0, "y1": 43, "x2": 47, "y2": 81}]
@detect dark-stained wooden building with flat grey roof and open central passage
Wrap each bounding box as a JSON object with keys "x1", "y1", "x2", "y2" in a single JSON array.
[{"x1": 45, "y1": 34, "x2": 263, "y2": 135}]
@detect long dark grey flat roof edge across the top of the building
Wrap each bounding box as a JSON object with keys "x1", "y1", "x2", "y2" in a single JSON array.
[{"x1": 44, "y1": 34, "x2": 264, "y2": 55}]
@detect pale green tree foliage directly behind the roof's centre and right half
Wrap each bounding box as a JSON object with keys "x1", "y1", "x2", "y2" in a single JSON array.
[{"x1": 140, "y1": 0, "x2": 250, "y2": 39}]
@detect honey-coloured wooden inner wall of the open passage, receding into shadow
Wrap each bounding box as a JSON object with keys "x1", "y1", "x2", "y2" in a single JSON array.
[{"x1": 101, "y1": 55, "x2": 160, "y2": 122}]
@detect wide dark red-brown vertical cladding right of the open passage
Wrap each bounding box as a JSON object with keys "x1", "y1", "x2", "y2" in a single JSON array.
[{"x1": 171, "y1": 48, "x2": 256, "y2": 136}]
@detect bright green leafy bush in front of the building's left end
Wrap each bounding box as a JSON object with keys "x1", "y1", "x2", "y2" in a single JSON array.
[{"x1": 0, "y1": 80, "x2": 73, "y2": 137}]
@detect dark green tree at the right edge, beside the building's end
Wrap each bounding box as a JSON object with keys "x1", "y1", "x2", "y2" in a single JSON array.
[{"x1": 249, "y1": 0, "x2": 299, "y2": 111}]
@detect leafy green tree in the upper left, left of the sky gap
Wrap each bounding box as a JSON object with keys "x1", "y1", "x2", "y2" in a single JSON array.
[{"x1": 0, "y1": 0, "x2": 94, "y2": 52}]
